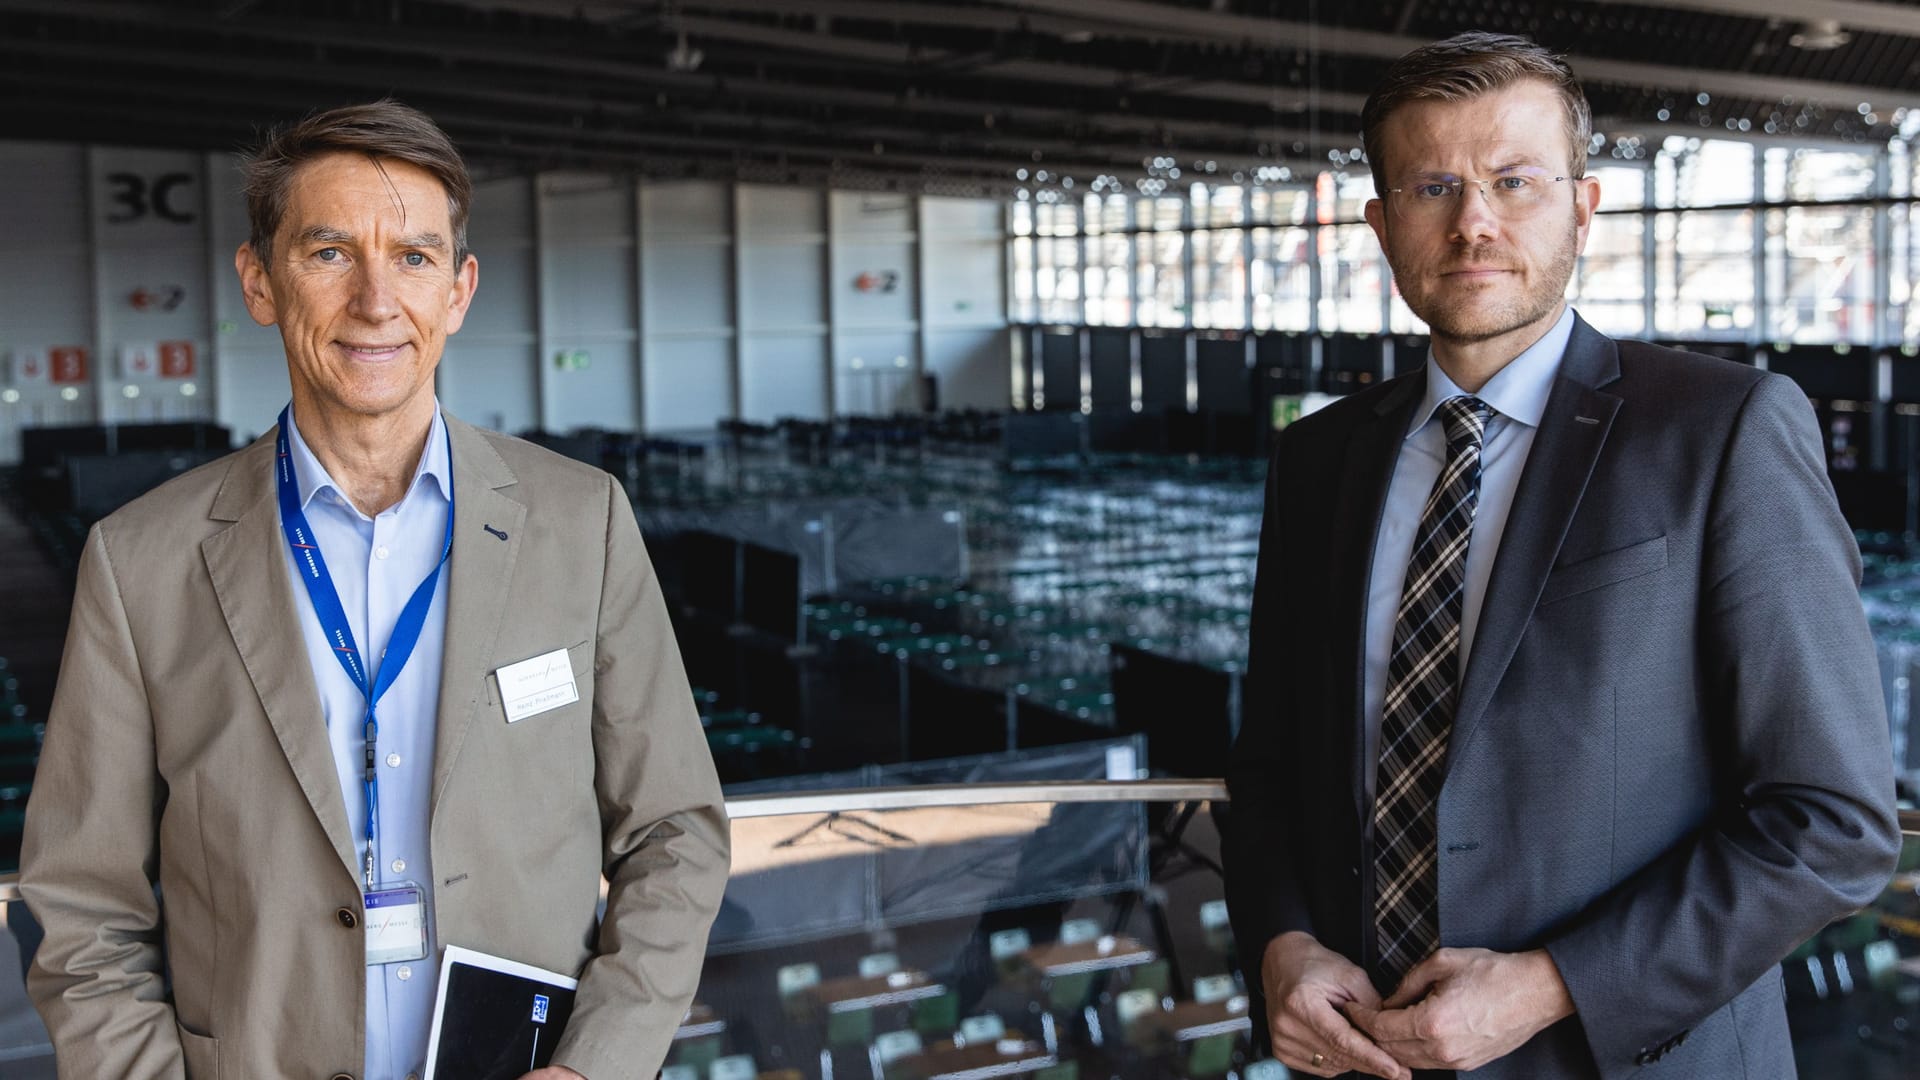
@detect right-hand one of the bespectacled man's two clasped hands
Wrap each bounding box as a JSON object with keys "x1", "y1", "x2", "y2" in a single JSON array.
[{"x1": 1346, "y1": 949, "x2": 1574, "y2": 1070}]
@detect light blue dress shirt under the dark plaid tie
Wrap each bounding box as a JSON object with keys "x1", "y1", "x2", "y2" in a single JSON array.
[{"x1": 1365, "y1": 307, "x2": 1572, "y2": 749}]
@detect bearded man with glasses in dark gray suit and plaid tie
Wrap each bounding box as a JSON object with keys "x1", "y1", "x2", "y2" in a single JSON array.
[{"x1": 1225, "y1": 35, "x2": 1899, "y2": 1080}]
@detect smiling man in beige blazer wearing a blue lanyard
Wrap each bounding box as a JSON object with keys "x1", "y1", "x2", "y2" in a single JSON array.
[{"x1": 21, "y1": 102, "x2": 728, "y2": 1080}]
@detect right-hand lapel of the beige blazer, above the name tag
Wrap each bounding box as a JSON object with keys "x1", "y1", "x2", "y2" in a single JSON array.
[{"x1": 432, "y1": 407, "x2": 526, "y2": 809}]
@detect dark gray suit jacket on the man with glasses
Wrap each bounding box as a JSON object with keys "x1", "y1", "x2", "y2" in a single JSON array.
[{"x1": 1225, "y1": 321, "x2": 1899, "y2": 1080}]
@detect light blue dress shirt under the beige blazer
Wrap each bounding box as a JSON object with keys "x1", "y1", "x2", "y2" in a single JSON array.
[{"x1": 280, "y1": 402, "x2": 453, "y2": 1080}]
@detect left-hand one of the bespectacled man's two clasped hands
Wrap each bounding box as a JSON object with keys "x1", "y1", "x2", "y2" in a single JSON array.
[{"x1": 1260, "y1": 932, "x2": 1413, "y2": 1080}]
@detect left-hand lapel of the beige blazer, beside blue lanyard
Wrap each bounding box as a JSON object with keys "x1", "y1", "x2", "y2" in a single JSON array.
[{"x1": 200, "y1": 432, "x2": 357, "y2": 874}]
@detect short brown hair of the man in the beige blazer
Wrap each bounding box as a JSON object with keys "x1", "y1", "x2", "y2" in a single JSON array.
[{"x1": 240, "y1": 98, "x2": 474, "y2": 267}]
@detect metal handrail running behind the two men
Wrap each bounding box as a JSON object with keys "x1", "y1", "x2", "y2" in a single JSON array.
[{"x1": 0, "y1": 780, "x2": 1920, "y2": 901}]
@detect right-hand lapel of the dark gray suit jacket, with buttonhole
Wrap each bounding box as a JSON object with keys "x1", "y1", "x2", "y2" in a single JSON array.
[{"x1": 1448, "y1": 319, "x2": 1620, "y2": 769}]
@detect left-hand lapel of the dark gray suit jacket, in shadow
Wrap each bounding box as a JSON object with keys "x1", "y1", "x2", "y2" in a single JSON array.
[{"x1": 1327, "y1": 369, "x2": 1427, "y2": 822}]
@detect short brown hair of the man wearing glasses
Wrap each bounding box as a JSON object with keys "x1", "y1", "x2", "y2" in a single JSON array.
[{"x1": 1359, "y1": 31, "x2": 1594, "y2": 194}]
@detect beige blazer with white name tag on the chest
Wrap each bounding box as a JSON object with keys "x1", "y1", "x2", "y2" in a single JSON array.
[{"x1": 21, "y1": 417, "x2": 728, "y2": 1080}]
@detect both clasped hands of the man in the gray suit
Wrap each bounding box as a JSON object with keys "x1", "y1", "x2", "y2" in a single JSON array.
[{"x1": 1261, "y1": 932, "x2": 1574, "y2": 1080}]
